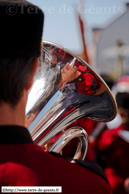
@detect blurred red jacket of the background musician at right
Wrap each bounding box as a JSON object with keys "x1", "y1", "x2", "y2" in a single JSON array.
[{"x1": 98, "y1": 125, "x2": 129, "y2": 194}]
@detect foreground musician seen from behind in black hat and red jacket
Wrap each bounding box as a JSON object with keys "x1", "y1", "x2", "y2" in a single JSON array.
[{"x1": 0, "y1": 0, "x2": 111, "y2": 194}]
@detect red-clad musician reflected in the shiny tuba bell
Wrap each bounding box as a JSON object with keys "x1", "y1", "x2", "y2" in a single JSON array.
[{"x1": 50, "y1": 47, "x2": 104, "y2": 96}]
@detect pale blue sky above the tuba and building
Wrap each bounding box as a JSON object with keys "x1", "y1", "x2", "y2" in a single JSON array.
[{"x1": 29, "y1": 0, "x2": 128, "y2": 51}]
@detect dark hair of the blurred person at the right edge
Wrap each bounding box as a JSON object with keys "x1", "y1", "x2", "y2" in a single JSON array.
[{"x1": 116, "y1": 92, "x2": 129, "y2": 110}]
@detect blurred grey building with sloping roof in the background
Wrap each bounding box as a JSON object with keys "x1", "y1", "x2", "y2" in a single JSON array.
[{"x1": 93, "y1": 3, "x2": 129, "y2": 79}]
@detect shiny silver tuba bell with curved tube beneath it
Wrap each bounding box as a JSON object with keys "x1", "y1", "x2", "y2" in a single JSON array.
[{"x1": 26, "y1": 41, "x2": 116, "y2": 160}]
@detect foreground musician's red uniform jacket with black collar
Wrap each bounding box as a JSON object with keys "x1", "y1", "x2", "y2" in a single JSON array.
[{"x1": 0, "y1": 126, "x2": 111, "y2": 194}]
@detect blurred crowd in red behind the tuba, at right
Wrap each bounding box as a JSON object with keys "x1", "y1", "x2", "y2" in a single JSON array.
[{"x1": 87, "y1": 75, "x2": 129, "y2": 194}]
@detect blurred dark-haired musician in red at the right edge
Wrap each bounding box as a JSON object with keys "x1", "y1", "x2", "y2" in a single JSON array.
[{"x1": 98, "y1": 92, "x2": 129, "y2": 194}]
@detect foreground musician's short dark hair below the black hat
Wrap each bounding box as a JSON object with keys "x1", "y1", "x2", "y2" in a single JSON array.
[{"x1": 0, "y1": 57, "x2": 33, "y2": 107}]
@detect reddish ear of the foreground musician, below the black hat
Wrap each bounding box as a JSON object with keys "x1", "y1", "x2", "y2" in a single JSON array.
[{"x1": 25, "y1": 58, "x2": 39, "y2": 90}]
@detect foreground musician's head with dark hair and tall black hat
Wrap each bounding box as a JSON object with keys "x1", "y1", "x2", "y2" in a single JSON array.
[{"x1": 0, "y1": 0, "x2": 44, "y2": 107}]
